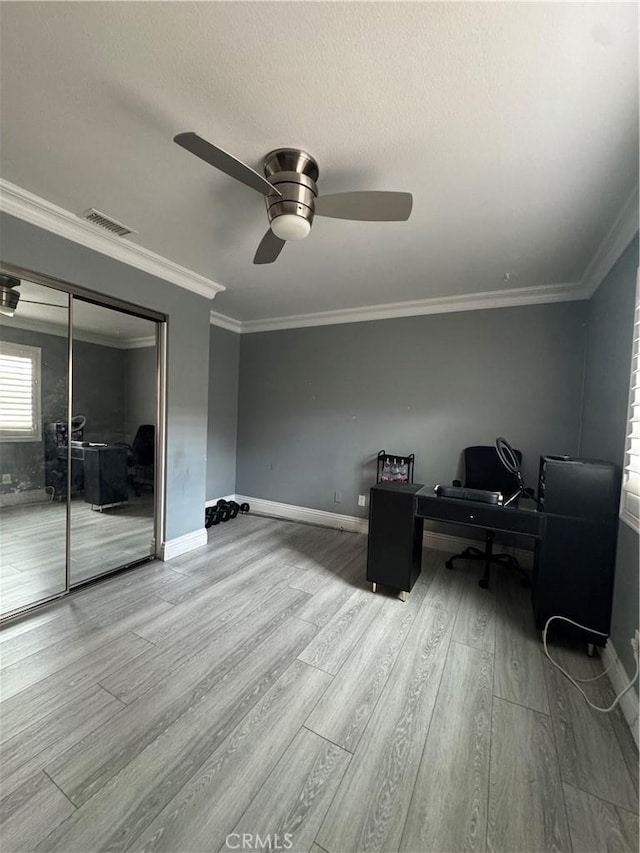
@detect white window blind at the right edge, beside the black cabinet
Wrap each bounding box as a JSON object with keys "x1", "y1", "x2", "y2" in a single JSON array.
[{"x1": 620, "y1": 271, "x2": 640, "y2": 533}]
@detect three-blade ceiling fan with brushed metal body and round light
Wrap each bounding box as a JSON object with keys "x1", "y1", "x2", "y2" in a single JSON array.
[{"x1": 173, "y1": 132, "x2": 413, "y2": 264}]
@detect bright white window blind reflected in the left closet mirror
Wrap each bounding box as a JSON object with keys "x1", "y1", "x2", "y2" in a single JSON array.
[{"x1": 0, "y1": 341, "x2": 42, "y2": 441}]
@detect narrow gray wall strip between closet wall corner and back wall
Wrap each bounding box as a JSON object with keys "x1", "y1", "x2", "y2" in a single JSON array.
[{"x1": 207, "y1": 326, "x2": 240, "y2": 500}]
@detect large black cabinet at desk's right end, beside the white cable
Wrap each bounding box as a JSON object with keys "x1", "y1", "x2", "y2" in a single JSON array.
[{"x1": 533, "y1": 456, "x2": 620, "y2": 646}]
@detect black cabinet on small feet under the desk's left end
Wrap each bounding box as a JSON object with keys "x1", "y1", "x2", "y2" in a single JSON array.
[{"x1": 367, "y1": 483, "x2": 423, "y2": 592}]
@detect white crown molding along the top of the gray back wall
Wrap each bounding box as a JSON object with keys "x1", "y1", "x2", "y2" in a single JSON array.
[{"x1": 211, "y1": 282, "x2": 587, "y2": 334}]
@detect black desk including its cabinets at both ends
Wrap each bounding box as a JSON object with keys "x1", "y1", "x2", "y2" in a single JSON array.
[{"x1": 367, "y1": 483, "x2": 616, "y2": 646}]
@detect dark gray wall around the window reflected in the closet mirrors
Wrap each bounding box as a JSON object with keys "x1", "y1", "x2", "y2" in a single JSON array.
[{"x1": 0, "y1": 320, "x2": 126, "y2": 488}]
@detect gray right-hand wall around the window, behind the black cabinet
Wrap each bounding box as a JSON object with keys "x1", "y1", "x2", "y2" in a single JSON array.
[{"x1": 580, "y1": 237, "x2": 640, "y2": 692}]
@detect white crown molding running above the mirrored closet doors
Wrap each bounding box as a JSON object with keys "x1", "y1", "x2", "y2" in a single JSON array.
[{"x1": 0, "y1": 179, "x2": 226, "y2": 299}]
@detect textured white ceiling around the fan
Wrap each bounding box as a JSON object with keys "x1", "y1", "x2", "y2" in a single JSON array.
[{"x1": 0, "y1": 2, "x2": 638, "y2": 320}]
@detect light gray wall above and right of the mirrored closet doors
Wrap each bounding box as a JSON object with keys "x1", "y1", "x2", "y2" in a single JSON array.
[{"x1": 0, "y1": 214, "x2": 211, "y2": 539}]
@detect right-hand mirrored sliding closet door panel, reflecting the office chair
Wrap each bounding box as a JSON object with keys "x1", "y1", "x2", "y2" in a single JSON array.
[{"x1": 70, "y1": 296, "x2": 157, "y2": 586}]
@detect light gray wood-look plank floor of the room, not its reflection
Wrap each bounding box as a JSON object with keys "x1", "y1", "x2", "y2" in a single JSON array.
[{"x1": 0, "y1": 515, "x2": 638, "y2": 853}]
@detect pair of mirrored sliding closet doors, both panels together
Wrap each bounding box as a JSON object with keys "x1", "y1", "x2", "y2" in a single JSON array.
[{"x1": 0, "y1": 276, "x2": 165, "y2": 618}]
